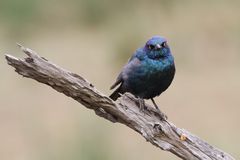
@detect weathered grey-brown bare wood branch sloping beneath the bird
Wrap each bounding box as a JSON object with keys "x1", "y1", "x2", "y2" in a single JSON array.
[{"x1": 6, "y1": 45, "x2": 234, "y2": 160}]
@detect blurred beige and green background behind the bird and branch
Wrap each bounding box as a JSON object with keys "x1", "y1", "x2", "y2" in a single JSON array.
[{"x1": 0, "y1": 0, "x2": 240, "y2": 160}]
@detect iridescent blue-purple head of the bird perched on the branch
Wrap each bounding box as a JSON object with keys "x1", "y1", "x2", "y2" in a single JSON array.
[{"x1": 144, "y1": 36, "x2": 171, "y2": 59}]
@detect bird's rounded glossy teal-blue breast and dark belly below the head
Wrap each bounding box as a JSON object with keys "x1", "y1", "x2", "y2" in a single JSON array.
[{"x1": 125, "y1": 57, "x2": 175, "y2": 98}]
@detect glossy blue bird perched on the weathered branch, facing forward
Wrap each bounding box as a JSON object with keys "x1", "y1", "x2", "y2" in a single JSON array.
[{"x1": 110, "y1": 36, "x2": 175, "y2": 111}]
